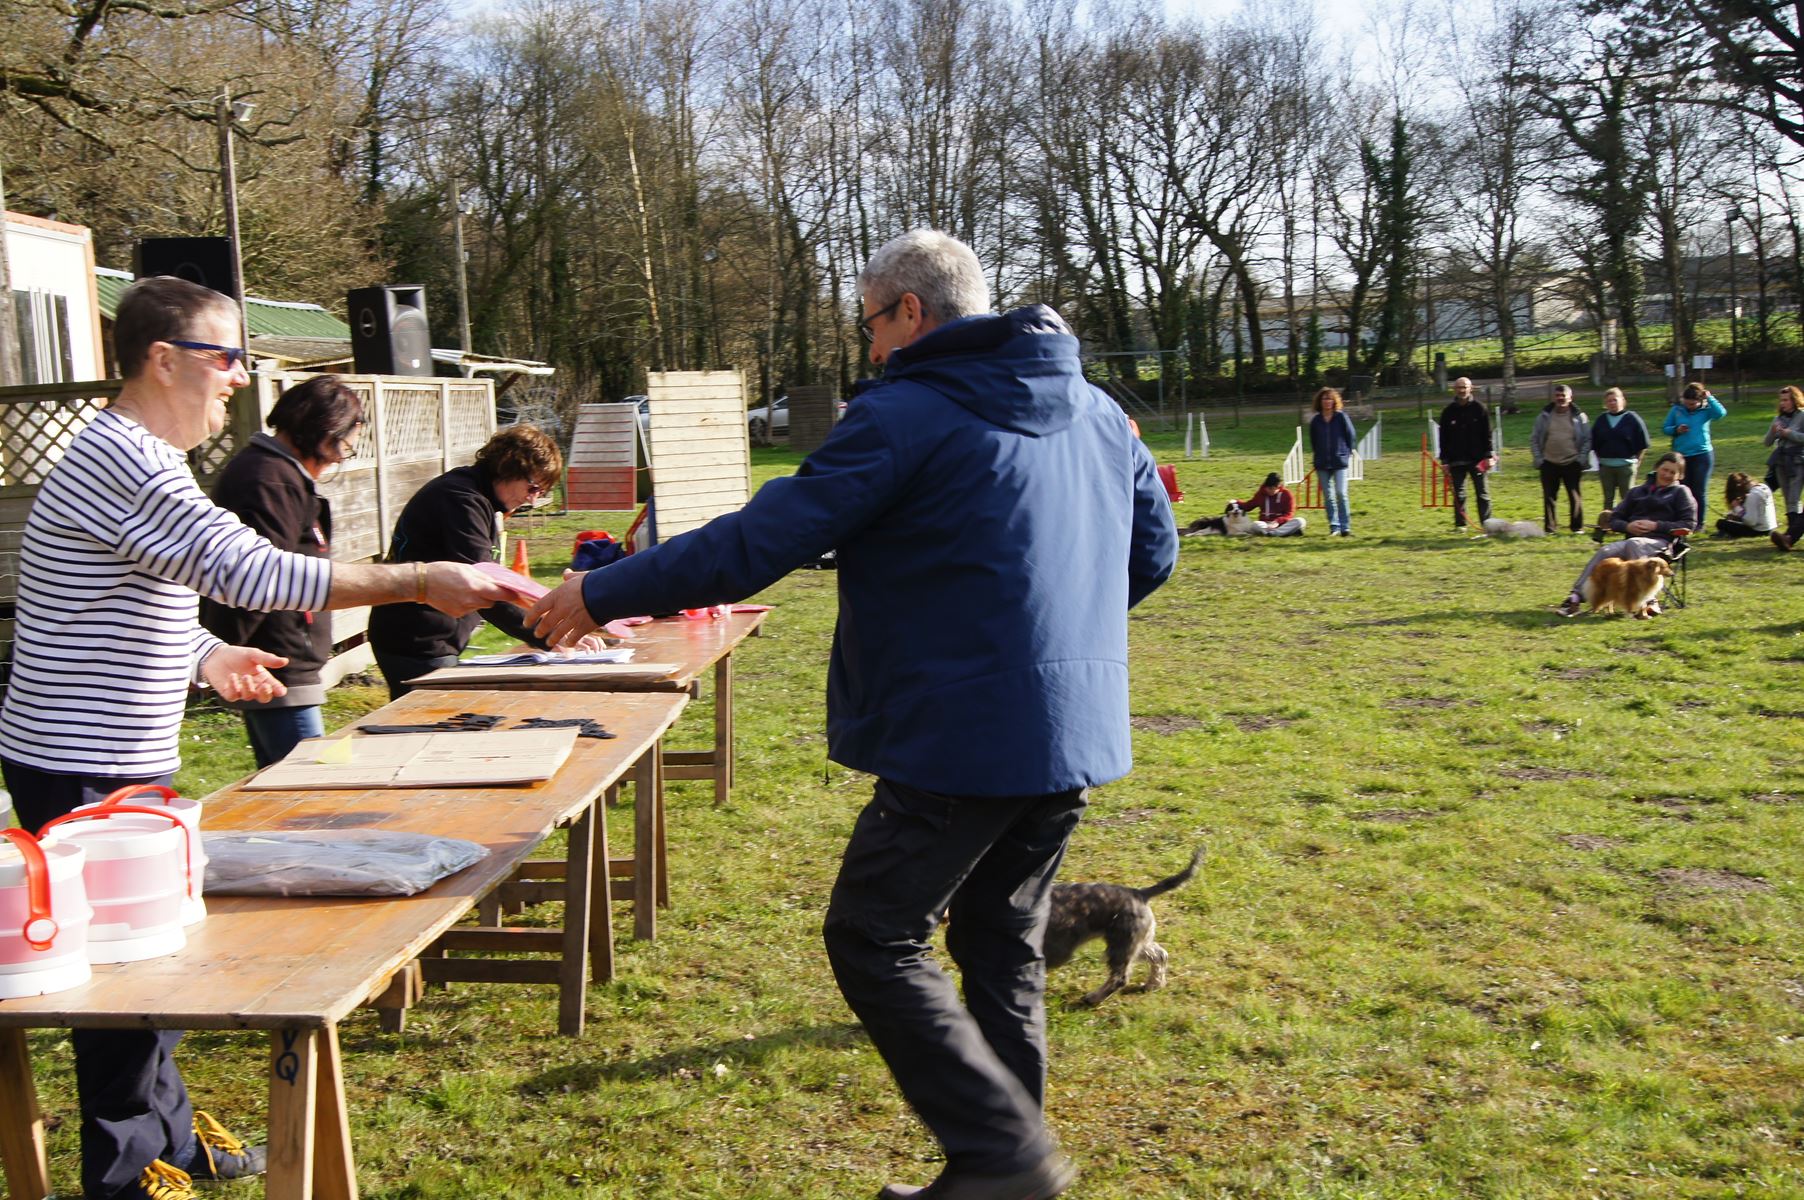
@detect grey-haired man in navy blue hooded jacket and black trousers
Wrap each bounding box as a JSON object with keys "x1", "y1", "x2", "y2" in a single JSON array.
[{"x1": 529, "y1": 229, "x2": 1178, "y2": 1200}]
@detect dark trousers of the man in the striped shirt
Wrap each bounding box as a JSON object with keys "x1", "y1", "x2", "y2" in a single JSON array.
[{"x1": 0, "y1": 760, "x2": 200, "y2": 1200}]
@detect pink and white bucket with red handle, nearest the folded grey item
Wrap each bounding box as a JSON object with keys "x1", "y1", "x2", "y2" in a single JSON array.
[{"x1": 40, "y1": 805, "x2": 189, "y2": 962}]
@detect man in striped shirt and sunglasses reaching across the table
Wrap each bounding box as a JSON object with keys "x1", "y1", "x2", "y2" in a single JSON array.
[{"x1": 0, "y1": 276, "x2": 507, "y2": 1200}]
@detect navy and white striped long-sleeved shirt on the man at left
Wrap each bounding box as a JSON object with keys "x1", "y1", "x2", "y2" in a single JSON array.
[{"x1": 0, "y1": 410, "x2": 332, "y2": 776}]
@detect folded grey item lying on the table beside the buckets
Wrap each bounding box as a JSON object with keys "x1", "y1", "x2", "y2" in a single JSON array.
[{"x1": 200, "y1": 830, "x2": 489, "y2": 895}]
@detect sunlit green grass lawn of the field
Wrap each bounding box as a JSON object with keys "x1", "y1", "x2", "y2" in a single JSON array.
[{"x1": 14, "y1": 388, "x2": 1804, "y2": 1200}]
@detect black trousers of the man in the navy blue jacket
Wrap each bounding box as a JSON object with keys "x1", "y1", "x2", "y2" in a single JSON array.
[{"x1": 824, "y1": 780, "x2": 1086, "y2": 1175}]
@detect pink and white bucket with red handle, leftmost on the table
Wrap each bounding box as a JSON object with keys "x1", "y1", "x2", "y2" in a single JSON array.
[{"x1": 0, "y1": 830, "x2": 94, "y2": 1000}]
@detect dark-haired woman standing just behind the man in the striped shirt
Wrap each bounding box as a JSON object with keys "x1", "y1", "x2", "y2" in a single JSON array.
[{"x1": 200, "y1": 375, "x2": 363, "y2": 767}]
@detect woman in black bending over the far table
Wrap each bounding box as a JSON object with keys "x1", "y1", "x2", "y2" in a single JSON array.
[{"x1": 370, "y1": 424, "x2": 563, "y2": 698}]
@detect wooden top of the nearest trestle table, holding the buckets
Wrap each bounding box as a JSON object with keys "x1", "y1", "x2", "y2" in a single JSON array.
[{"x1": 0, "y1": 691, "x2": 687, "y2": 1029}]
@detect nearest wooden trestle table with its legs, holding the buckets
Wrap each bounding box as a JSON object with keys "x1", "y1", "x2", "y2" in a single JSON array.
[{"x1": 0, "y1": 691, "x2": 687, "y2": 1200}]
